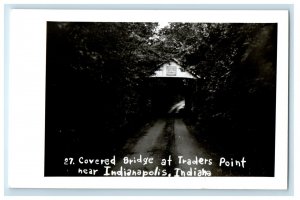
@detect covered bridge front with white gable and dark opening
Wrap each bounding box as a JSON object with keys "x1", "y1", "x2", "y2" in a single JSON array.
[{"x1": 149, "y1": 62, "x2": 196, "y2": 116}]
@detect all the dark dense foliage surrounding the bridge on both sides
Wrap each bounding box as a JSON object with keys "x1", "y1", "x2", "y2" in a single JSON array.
[{"x1": 46, "y1": 22, "x2": 277, "y2": 175}]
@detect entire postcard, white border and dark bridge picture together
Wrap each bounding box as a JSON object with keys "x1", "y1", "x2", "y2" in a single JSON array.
[{"x1": 7, "y1": 9, "x2": 292, "y2": 192}]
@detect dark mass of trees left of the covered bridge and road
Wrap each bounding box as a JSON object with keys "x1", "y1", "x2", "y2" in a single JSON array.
[{"x1": 46, "y1": 22, "x2": 163, "y2": 159}]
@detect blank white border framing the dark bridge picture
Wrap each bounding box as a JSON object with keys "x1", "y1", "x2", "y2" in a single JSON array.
[{"x1": 8, "y1": 9, "x2": 288, "y2": 189}]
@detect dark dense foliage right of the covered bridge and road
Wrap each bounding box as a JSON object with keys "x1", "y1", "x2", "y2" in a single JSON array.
[{"x1": 161, "y1": 23, "x2": 277, "y2": 174}]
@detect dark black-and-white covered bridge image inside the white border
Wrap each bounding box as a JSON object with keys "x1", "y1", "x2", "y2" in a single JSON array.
[{"x1": 44, "y1": 21, "x2": 278, "y2": 177}]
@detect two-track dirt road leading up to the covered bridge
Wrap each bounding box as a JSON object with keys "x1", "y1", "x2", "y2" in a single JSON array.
[{"x1": 112, "y1": 117, "x2": 221, "y2": 176}]
